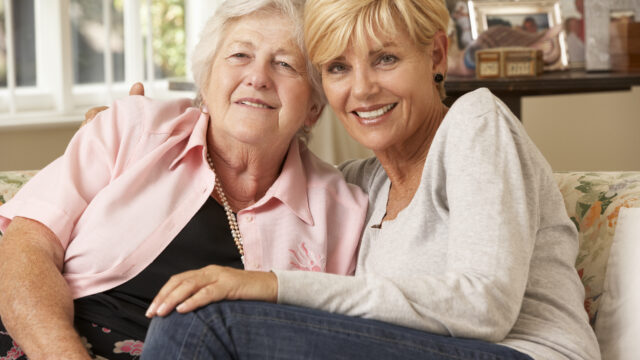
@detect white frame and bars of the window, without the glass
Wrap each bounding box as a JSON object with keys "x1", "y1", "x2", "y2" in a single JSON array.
[{"x1": 0, "y1": 0, "x2": 208, "y2": 129}]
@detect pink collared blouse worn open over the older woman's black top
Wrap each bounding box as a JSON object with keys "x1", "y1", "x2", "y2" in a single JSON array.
[{"x1": 0, "y1": 96, "x2": 368, "y2": 298}]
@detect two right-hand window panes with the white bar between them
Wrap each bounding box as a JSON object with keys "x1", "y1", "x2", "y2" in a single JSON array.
[{"x1": 69, "y1": 0, "x2": 186, "y2": 107}]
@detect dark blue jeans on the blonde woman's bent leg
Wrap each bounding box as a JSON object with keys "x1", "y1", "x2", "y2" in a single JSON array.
[{"x1": 142, "y1": 301, "x2": 532, "y2": 360}]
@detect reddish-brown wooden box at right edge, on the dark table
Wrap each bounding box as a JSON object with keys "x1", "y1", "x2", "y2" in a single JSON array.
[{"x1": 609, "y1": 21, "x2": 640, "y2": 71}]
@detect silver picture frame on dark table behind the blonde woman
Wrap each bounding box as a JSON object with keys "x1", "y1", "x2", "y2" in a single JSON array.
[{"x1": 468, "y1": 0, "x2": 569, "y2": 71}]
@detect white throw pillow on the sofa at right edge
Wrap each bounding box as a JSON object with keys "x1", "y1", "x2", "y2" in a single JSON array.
[{"x1": 595, "y1": 208, "x2": 640, "y2": 360}]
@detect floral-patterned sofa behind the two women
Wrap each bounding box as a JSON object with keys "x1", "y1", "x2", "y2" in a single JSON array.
[{"x1": 0, "y1": 171, "x2": 640, "y2": 358}]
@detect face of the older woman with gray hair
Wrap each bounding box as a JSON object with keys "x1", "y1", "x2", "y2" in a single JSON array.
[{"x1": 203, "y1": 12, "x2": 317, "y2": 146}]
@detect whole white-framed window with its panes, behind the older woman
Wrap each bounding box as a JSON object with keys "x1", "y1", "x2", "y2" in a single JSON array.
[{"x1": 0, "y1": 0, "x2": 199, "y2": 127}]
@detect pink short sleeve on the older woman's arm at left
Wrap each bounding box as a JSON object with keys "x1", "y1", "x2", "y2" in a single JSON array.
[{"x1": 0, "y1": 97, "x2": 141, "y2": 249}]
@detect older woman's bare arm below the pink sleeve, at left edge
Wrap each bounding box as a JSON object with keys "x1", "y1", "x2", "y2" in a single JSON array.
[{"x1": 0, "y1": 217, "x2": 90, "y2": 359}]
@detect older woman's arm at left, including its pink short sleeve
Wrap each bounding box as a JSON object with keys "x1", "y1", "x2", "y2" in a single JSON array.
[{"x1": 0, "y1": 92, "x2": 146, "y2": 359}]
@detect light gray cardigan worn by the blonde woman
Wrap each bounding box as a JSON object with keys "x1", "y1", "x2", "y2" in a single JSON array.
[{"x1": 275, "y1": 89, "x2": 600, "y2": 360}]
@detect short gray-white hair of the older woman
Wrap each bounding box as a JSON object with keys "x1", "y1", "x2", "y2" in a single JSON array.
[{"x1": 191, "y1": 0, "x2": 327, "y2": 108}]
